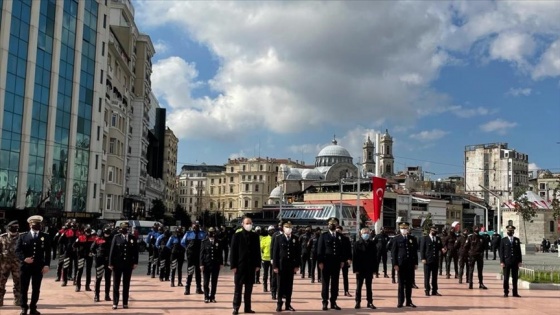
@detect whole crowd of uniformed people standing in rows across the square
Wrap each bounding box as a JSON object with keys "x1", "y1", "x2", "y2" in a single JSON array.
[{"x1": 0, "y1": 216, "x2": 521, "y2": 315}]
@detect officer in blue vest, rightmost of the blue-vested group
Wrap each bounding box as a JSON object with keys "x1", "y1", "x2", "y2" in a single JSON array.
[{"x1": 181, "y1": 223, "x2": 206, "y2": 295}]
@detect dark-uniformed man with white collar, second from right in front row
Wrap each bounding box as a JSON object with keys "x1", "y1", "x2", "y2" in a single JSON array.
[{"x1": 420, "y1": 226, "x2": 443, "y2": 296}]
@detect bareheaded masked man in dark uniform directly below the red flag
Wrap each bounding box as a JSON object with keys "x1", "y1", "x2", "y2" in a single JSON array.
[{"x1": 352, "y1": 228, "x2": 378, "y2": 310}]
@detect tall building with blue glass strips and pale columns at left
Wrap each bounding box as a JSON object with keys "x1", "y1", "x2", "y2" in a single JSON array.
[{"x1": 0, "y1": 0, "x2": 108, "y2": 222}]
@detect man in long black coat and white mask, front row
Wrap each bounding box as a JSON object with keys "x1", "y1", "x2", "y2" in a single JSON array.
[{"x1": 230, "y1": 217, "x2": 261, "y2": 314}]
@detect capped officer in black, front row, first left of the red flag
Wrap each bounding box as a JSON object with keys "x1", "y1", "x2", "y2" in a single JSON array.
[{"x1": 317, "y1": 218, "x2": 346, "y2": 311}]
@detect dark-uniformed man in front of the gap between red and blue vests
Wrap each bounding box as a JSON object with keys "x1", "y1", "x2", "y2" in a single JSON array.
[{"x1": 109, "y1": 222, "x2": 138, "y2": 310}]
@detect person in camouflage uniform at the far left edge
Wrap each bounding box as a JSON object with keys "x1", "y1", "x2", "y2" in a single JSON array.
[{"x1": 0, "y1": 220, "x2": 21, "y2": 306}]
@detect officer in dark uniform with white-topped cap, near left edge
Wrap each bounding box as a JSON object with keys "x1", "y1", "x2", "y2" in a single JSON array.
[{"x1": 16, "y1": 215, "x2": 51, "y2": 315}]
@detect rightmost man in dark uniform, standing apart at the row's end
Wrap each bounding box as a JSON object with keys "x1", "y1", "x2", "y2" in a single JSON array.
[{"x1": 500, "y1": 225, "x2": 523, "y2": 297}]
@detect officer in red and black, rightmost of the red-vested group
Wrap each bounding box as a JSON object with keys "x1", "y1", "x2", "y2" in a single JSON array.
[{"x1": 90, "y1": 227, "x2": 112, "y2": 302}]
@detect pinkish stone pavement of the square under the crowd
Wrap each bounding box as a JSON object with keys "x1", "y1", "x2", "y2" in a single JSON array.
[{"x1": 0, "y1": 253, "x2": 560, "y2": 315}]
